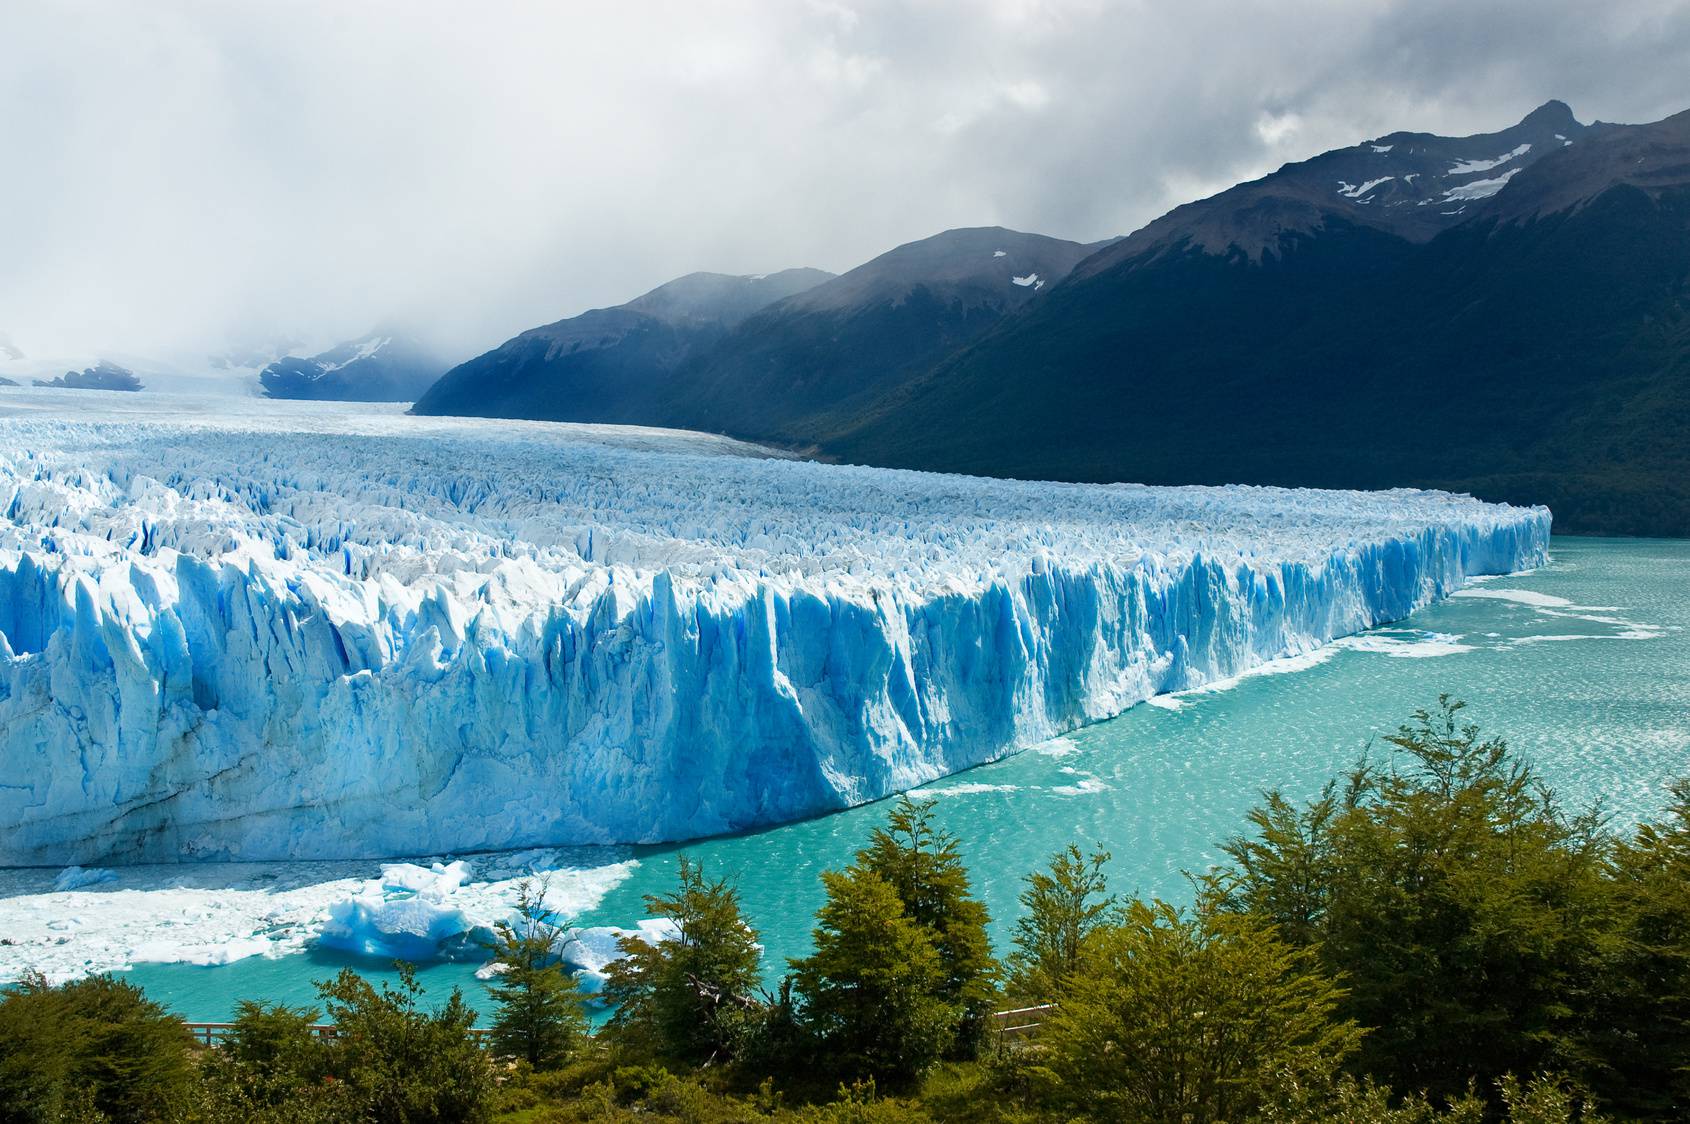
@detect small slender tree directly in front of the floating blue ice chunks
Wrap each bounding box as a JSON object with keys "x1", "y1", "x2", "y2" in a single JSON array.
[{"x1": 488, "y1": 879, "x2": 586, "y2": 1068}]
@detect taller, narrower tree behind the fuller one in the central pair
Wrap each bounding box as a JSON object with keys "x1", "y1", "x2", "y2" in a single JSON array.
[{"x1": 857, "y1": 796, "x2": 997, "y2": 1056}]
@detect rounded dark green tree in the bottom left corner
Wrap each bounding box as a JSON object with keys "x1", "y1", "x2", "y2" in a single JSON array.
[{"x1": 0, "y1": 974, "x2": 193, "y2": 1124}]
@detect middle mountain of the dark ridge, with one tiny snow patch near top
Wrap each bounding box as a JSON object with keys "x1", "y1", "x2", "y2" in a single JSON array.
[{"x1": 657, "y1": 226, "x2": 1097, "y2": 445}]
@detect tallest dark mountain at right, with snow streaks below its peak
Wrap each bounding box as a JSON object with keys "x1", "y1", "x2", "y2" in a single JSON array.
[{"x1": 828, "y1": 101, "x2": 1690, "y2": 534}]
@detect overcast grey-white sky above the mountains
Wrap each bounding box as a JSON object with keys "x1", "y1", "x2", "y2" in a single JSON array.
[{"x1": 0, "y1": 0, "x2": 1690, "y2": 357}]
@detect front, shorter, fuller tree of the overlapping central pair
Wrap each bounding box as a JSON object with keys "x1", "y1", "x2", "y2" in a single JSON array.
[{"x1": 791, "y1": 865, "x2": 960, "y2": 1085}]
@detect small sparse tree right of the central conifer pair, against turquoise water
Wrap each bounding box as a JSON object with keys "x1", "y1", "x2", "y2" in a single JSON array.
[{"x1": 1009, "y1": 843, "x2": 1115, "y2": 1002}]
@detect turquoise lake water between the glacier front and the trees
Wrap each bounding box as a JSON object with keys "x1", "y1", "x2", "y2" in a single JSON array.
[{"x1": 59, "y1": 539, "x2": 1690, "y2": 1019}]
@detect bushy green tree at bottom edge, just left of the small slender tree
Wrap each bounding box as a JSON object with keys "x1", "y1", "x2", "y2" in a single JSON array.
[{"x1": 318, "y1": 963, "x2": 493, "y2": 1124}]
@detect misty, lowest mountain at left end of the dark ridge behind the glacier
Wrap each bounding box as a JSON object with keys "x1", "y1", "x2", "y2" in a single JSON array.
[{"x1": 412, "y1": 269, "x2": 833, "y2": 424}]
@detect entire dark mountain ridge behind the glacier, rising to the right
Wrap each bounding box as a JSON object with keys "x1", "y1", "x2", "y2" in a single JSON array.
[{"x1": 416, "y1": 101, "x2": 1690, "y2": 534}]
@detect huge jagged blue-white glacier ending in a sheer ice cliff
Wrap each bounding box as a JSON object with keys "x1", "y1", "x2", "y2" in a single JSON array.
[{"x1": 0, "y1": 389, "x2": 1550, "y2": 867}]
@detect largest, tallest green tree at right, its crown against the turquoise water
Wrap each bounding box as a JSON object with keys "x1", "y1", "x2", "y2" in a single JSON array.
[{"x1": 1227, "y1": 696, "x2": 1611, "y2": 1097}]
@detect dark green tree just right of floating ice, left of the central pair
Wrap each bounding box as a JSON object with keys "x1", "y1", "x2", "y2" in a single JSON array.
[{"x1": 605, "y1": 855, "x2": 762, "y2": 1061}]
